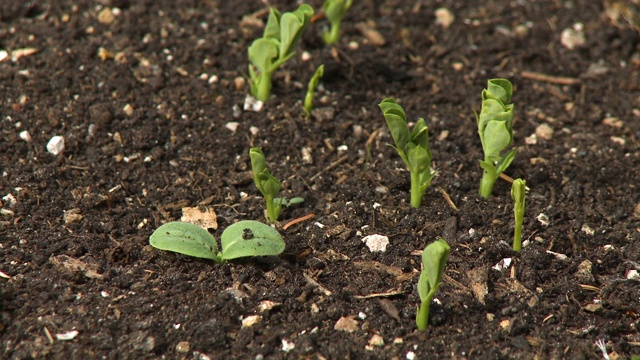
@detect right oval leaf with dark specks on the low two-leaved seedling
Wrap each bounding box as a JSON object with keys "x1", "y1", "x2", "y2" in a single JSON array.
[{"x1": 221, "y1": 220, "x2": 285, "y2": 260}]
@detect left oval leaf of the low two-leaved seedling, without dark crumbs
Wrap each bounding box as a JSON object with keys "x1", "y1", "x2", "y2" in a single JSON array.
[{"x1": 149, "y1": 221, "x2": 218, "y2": 261}]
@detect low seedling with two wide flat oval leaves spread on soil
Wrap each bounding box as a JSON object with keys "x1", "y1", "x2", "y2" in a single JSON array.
[{"x1": 149, "y1": 220, "x2": 285, "y2": 262}]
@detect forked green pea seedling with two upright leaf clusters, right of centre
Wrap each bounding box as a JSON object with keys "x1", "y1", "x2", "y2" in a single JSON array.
[{"x1": 379, "y1": 98, "x2": 434, "y2": 208}]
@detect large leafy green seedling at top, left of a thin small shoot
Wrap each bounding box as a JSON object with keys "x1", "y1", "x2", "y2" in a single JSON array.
[{"x1": 249, "y1": 4, "x2": 313, "y2": 101}]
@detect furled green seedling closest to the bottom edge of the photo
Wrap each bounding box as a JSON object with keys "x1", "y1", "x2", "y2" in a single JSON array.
[{"x1": 416, "y1": 238, "x2": 451, "y2": 331}]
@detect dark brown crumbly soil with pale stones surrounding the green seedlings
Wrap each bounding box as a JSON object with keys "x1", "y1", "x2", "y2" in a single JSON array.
[{"x1": 0, "y1": 0, "x2": 640, "y2": 359}]
